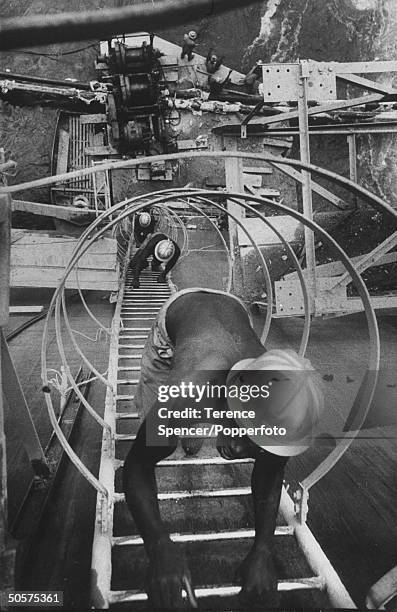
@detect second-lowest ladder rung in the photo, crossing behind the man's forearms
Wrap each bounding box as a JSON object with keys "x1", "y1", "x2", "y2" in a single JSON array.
[{"x1": 113, "y1": 525, "x2": 294, "y2": 546}]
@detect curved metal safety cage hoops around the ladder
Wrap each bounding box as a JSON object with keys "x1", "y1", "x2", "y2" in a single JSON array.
[{"x1": 0, "y1": 152, "x2": 390, "y2": 504}]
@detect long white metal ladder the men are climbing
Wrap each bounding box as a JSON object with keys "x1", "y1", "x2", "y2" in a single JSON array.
[{"x1": 92, "y1": 270, "x2": 355, "y2": 610}]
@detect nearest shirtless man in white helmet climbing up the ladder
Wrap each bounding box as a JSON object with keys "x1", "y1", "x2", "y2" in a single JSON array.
[{"x1": 123, "y1": 288, "x2": 322, "y2": 610}]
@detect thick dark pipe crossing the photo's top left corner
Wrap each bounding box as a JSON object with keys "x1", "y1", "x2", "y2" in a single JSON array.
[{"x1": 0, "y1": 0, "x2": 258, "y2": 50}]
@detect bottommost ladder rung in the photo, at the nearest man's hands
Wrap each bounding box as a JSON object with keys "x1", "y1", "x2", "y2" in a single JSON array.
[{"x1": 109, "y1": 576, "x2": 324, "y2": 604}]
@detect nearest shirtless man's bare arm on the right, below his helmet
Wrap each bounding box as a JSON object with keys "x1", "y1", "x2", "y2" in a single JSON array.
[{"x1": 235, "y1": 452, "x2": 287, "y2": 607}]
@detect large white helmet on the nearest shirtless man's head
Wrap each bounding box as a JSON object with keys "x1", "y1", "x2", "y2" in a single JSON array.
[{"x1": 227, "y1": 349, "x2": 324, "y2": 457}]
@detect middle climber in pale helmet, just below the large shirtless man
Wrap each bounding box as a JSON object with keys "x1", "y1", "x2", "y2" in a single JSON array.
[{"x1": 130, "y1": 233, "x2": 181, "y2": 289}]
